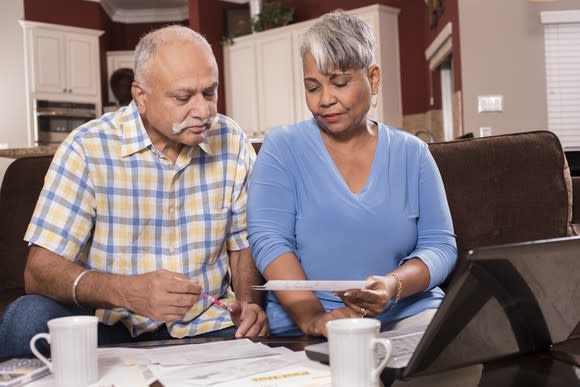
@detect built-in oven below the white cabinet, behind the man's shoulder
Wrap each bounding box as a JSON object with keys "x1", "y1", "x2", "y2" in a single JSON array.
[{"x1": 36, "y1": 100, "x2": 97, "y2": 145}]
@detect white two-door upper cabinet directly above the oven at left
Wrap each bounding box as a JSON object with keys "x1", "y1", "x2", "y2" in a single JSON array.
[{"x1": 21, "y1": 21, "x2": 103, "y2": 101}]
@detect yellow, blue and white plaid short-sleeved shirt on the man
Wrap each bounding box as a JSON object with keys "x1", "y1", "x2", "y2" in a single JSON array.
[{"x1": 25, "y1": 102, "x2": 256, "y2": 337}]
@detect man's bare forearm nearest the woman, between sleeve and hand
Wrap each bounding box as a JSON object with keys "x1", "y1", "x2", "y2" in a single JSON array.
[{"x1": 229, "y1": 248, "x2": 264, "y2": 305}]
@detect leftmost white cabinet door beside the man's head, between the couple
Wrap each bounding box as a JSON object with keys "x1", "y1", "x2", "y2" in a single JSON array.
[{"x1": 224, "y1": 41, "x2": 262, "y2": 137}]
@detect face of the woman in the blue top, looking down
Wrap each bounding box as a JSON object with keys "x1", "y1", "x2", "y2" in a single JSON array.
[{"x1": 303, "y1": 53, "x2": 380, "y2": 136}]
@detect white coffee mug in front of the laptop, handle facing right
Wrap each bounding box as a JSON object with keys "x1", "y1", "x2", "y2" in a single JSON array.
[{"x1": 326, "y1": 318, "x2": 392, "y2": 387}]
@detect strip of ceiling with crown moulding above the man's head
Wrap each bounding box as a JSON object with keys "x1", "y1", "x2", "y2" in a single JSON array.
[{"x1": 87, "y1": 0, "x2": 248, "y2": 23}]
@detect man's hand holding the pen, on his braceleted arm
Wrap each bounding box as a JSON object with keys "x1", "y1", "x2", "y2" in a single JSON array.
[{"x1": 124, "y1": 270, "x2": 202, "y2": 321}]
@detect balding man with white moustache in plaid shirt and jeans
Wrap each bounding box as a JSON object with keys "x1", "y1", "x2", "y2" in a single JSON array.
[{"x1": 0, "y1": 26, "x2": 268, "y2": 357}]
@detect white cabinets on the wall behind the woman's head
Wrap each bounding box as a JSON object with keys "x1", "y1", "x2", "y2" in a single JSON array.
[{"x1": 224, "y1": 5, "x2": 402, "y2": 138}]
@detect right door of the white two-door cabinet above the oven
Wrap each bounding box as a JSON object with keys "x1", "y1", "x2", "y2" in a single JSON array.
[{"x1": 64, "y1": 34, "x2": 100, "y2": 96}]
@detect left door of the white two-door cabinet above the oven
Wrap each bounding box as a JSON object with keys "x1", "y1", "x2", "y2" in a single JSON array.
[{"x1": 30, "y1": 30, "x2": 67, "y2": 93}]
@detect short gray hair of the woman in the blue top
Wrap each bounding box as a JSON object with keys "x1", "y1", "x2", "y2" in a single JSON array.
[{"x1": 300, "y1": 10, "x2": 375, "y2": 74}]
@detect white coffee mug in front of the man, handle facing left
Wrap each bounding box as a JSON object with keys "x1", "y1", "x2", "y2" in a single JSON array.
[{"x1": 30, "y1": 316, "x2": 99, "y2": 387}]
